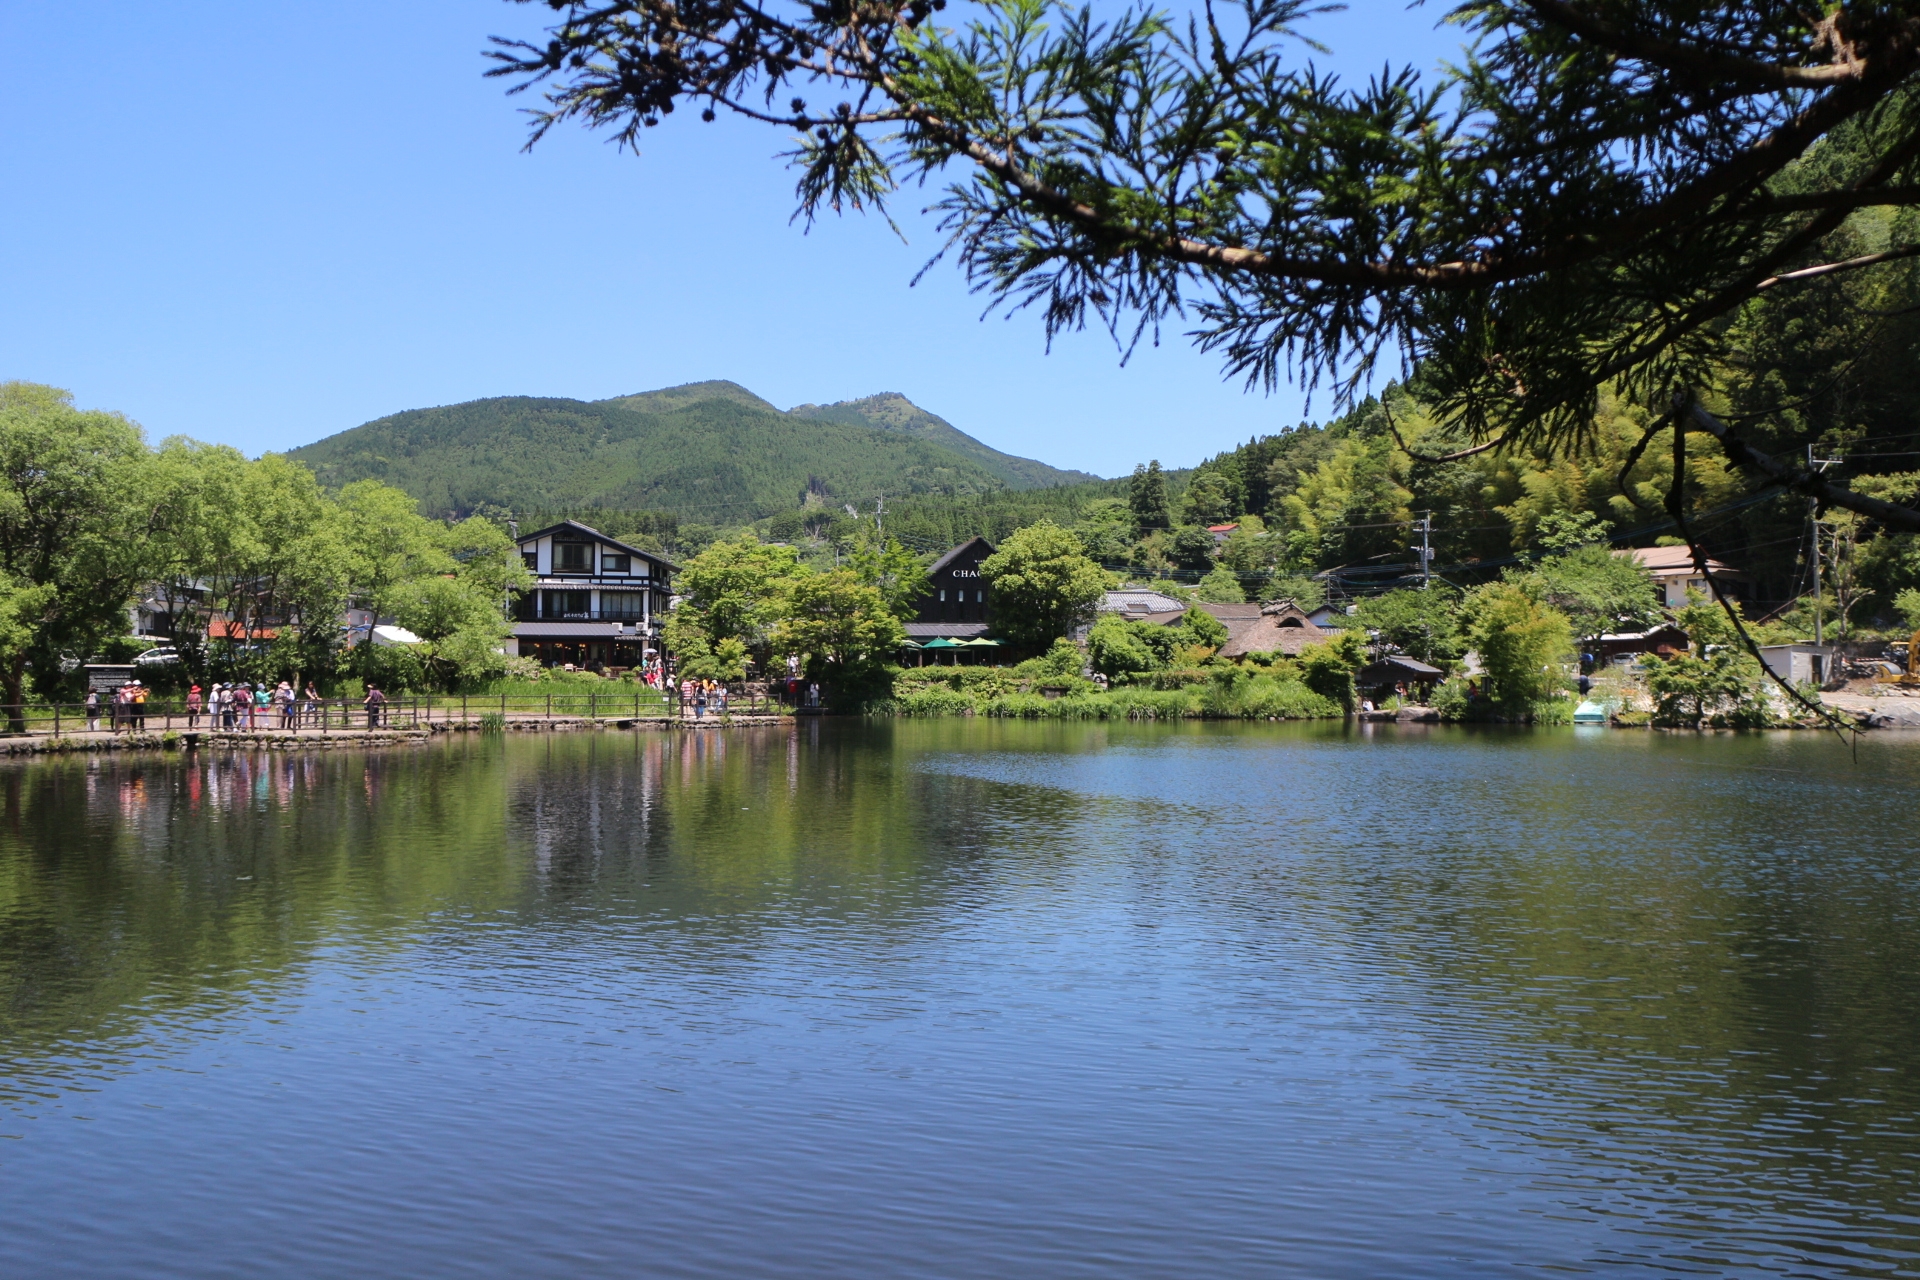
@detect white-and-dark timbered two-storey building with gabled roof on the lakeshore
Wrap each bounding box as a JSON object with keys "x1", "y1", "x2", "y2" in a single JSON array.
[{"x1": 509, "y1": 520, "x2": 680, "y2": 670}]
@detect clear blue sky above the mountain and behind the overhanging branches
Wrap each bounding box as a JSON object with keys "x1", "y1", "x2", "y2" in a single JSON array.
[{"x1": 0, "y1": 0, "x2": 1457, "y2": 474}]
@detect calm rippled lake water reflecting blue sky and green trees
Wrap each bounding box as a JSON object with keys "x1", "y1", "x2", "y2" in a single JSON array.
[{"x1": 0, "y1": 722, "x2": 1920, "y2": 1278}]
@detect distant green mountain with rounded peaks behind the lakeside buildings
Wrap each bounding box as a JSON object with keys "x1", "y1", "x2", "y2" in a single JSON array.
[{"x1": 290, "y1": 382, "x2": 1083, "y2": 524}]
